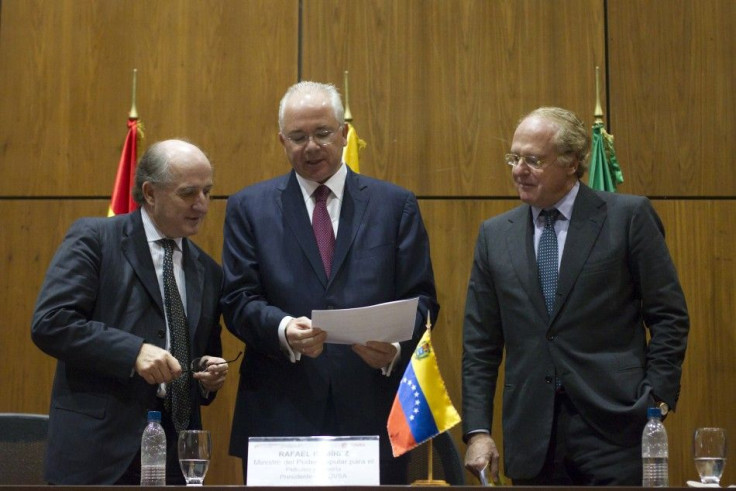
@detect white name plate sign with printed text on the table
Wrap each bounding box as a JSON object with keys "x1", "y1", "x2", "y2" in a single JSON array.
[{"x1": 246, "y1": 435, "x2": 380, "y2": 486}]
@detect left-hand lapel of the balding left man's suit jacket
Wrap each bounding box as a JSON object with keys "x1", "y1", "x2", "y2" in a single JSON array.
[{"x1": 120, "y1": 210, "x2": 164, "y2": 315}]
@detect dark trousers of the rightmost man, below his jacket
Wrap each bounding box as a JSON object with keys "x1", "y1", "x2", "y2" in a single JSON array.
[{"x1": 514, "y1": 392, "x2": 642, "y2": 486}]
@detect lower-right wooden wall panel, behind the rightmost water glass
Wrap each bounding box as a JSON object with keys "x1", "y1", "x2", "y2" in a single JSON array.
[{"x1": 654, "y1": 200, "x2": 736, "y2": 486}]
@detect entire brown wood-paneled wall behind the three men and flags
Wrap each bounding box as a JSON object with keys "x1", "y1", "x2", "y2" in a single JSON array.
[{"x1": 0, "y1": 0, "x2": 736, "y2": 486}]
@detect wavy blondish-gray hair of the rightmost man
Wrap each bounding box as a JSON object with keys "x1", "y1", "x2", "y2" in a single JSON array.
[{"x1": 522, "y1": 107, "x2": 590, "y2": 179}]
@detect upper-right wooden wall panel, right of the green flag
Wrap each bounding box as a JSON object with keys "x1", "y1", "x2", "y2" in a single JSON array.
[{"x1": 608, "y1": 0, "x2": 736, "y2": 196}]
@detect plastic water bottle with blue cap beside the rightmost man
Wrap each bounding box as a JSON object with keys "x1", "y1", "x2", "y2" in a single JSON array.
[{"x1": 641, "y1": 407, "x2": 670, "y2": 488}]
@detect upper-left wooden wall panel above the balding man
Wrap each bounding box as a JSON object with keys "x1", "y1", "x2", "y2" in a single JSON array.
[{"x1": 0, "y1": 0, "x2": 299, "y2": 197}]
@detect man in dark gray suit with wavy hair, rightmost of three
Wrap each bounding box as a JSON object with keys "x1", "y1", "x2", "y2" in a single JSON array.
[{"x1": 463, "y1": 108, "x2": 689, "y2": 486}]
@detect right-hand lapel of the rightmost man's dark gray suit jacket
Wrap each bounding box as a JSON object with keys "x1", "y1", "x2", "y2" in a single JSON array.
[{"x1": 552, "y1": 183, "x2": 607, "y2": 317}]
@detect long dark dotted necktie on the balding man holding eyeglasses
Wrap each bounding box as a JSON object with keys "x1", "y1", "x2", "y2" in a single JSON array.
[{"x1": 159, "y1": 239, "x2": 191, "y2": 431}]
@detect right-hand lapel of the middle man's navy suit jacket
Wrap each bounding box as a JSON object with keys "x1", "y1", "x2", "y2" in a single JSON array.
[{"x1": 332, "y1": 168, "x2": 370, "y2": 286}]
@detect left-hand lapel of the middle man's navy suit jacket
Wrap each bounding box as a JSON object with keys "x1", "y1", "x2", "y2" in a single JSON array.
[{"x1": 277, "y1": 171, "x2": 334, "y2": 286}]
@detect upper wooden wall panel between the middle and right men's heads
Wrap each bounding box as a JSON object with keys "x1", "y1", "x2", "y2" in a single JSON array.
[{"x1": 303, "y1": 0, "x2": 604, "y2": 196}]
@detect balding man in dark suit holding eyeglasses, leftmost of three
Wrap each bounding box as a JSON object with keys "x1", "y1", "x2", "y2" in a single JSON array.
[{"x1": 31, "y1": 140, "x2": 227, "y2": 485}]
